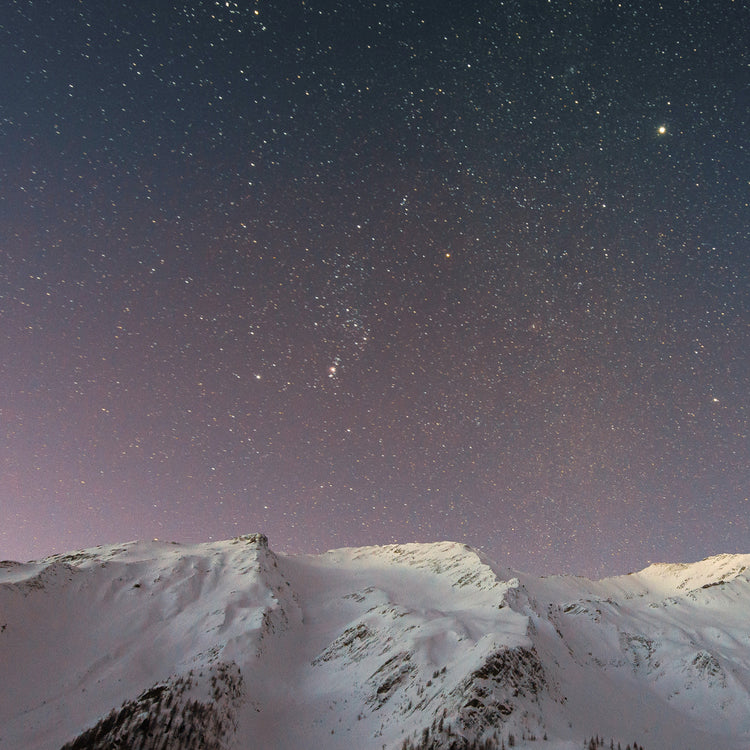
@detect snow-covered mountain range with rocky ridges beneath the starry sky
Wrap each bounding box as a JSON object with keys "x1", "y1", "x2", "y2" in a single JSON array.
[{"x1": 0, "y1": 534, "x2": 750, "y2": 750}]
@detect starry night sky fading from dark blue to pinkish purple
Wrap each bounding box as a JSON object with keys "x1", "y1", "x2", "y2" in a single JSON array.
[{"x1": 0, "y1": 0, "x2": 750, "y2": 575}]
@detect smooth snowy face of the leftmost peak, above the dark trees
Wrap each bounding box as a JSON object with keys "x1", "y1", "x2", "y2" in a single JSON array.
[{"x1": 0, "y1": 536, "x2": 299, "y2": 750}]
